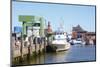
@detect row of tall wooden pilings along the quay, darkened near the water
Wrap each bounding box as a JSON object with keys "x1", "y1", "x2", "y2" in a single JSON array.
[{"x1": 13, "y1": 35, "x2": 46, "y2": 64}]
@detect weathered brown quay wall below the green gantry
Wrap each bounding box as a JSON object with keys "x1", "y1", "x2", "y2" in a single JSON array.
[{"x1": 11, "y1": 37, "x2": 45, "y2": 62}]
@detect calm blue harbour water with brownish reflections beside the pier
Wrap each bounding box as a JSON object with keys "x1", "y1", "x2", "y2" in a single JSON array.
[{"x1": 19, "y1": 45, "x2": 95, "y2": 64}]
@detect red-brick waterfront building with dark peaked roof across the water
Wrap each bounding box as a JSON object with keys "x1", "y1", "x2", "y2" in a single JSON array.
[{"x1": 72, "y1": 25, "x2": 96, "y2": 44}]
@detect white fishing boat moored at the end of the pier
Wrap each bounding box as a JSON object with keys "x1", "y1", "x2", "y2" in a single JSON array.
[{"x1": 52, "y1": 31, "x2": 70, "y2": 51}]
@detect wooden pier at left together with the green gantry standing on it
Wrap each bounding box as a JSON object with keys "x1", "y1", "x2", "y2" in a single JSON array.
[{"x1": 11, "y1": 15, "x2": 46, "y2": 62}]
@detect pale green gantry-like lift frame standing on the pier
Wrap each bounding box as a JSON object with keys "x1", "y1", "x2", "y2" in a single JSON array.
[{"x1": 19, "y1": 15, "x2": 45, "y2": 37}]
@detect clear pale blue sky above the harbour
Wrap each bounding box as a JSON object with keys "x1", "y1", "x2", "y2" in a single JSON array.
[{"x1": 12, "y1": 1, "x2": 96, "y2": 33}]
